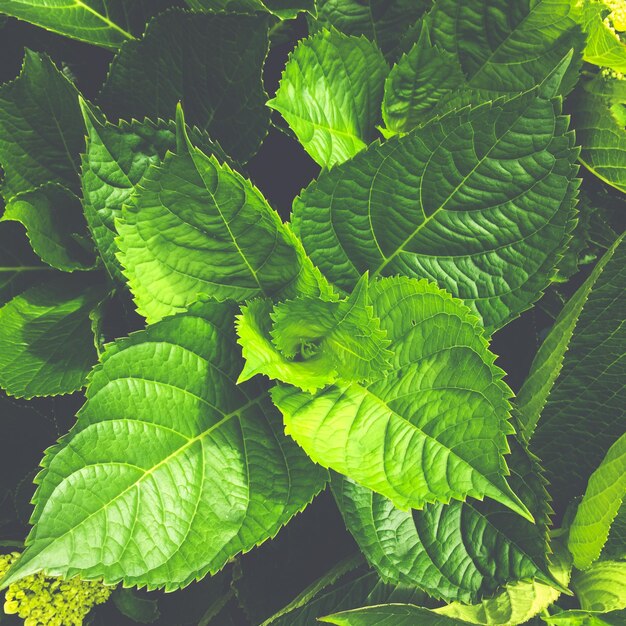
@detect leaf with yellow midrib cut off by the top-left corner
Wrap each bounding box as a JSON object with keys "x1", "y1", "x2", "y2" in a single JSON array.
[{"x1": 0, "y1": 0, "x2": 171, "y2": 50}]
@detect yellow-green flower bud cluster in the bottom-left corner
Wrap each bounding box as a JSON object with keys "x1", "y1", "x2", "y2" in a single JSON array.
[{"x1": 0, "y1": 552, "x2": 112, "y2": 626}]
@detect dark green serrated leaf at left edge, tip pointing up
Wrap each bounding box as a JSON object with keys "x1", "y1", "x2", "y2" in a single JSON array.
[{"x1": 0, "y1": 49, "x2": 84, "y2": 201}]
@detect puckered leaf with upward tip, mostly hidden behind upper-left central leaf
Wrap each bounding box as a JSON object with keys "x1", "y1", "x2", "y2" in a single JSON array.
[{"x1": 80, "y1": 99, "x2": 227, "y2": 282}]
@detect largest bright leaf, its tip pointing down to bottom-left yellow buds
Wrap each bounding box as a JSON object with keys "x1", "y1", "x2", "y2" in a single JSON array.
[{"x1": 1, "y1": 301, "x2": 327, "y2": 590}]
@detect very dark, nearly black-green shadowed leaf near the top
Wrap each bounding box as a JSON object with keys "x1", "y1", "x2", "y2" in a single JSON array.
[{"x1": 100, "y1": 10, "x2": 269, "y2": 161}]
